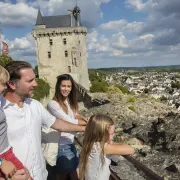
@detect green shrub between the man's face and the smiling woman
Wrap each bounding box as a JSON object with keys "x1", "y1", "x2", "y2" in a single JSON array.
[{"x1": 33, "y1": 79, "x2": 50, "y2": 101}]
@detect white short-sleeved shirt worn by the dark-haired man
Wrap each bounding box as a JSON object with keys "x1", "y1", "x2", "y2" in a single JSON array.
[{"x1": 1, "y1": 98, "x2": 56, "y2": 180}]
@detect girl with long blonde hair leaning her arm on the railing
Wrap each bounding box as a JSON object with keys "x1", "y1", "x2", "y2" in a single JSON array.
[{"x1": 79, "y1": 115, "x2": 134, "y2": 180}]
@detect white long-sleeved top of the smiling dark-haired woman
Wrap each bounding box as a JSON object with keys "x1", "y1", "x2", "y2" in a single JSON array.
[{"x1": 47, "y1": 100, "x2": 78, "y2": 145}]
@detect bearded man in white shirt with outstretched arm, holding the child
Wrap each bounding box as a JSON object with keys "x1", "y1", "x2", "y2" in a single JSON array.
[{"x1": 1, "y1": 61, "x2": 85, "y2": 180}]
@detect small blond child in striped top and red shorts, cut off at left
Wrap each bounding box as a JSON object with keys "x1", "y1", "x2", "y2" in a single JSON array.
[{"x1": 0, "y1": 66, "x2": 31, "y2": 180}]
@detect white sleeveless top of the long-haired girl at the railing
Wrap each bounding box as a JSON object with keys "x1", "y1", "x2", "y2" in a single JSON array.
[{"x1": 85, "y1": 143, "x2": 111, "y2": 180}]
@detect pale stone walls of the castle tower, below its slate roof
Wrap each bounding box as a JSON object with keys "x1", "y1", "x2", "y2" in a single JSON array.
[{"x1": 32, "y1": 26, "x2": 89, "y2": 97}]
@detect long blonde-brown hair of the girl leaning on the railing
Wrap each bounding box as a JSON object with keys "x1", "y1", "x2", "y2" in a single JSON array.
[{"x1": 79, "y1": 114, "x2": 114, "y2": 180}]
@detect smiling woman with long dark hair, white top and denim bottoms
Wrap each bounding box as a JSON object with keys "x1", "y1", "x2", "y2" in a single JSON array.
[{"x1": 47, "y1": 74, "x2": 86, "y2": 180}]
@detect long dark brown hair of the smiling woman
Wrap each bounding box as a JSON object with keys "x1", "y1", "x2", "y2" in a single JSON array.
[{"x1": 53, "y1": 74, "x2": 78, "y2": 113}]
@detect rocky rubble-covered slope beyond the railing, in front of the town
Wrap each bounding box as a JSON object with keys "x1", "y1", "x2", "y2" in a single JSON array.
[{"x1": 82, "y1": 93, "x2": 180, "y2": 180}]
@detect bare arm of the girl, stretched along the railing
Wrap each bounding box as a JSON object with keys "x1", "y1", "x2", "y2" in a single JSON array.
[{"x1": 104, "y1": 143, "x2": 135, "y2": 155}]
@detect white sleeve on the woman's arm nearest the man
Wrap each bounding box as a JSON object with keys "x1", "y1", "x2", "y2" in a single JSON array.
[{"x1": 47, "y1": 100, "x2": 78, "y2": 124}]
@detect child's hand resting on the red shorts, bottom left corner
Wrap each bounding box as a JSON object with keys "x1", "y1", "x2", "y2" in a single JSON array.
[{"x1": 1, "y1": 159, "x2": 16, "y2": 178}]
